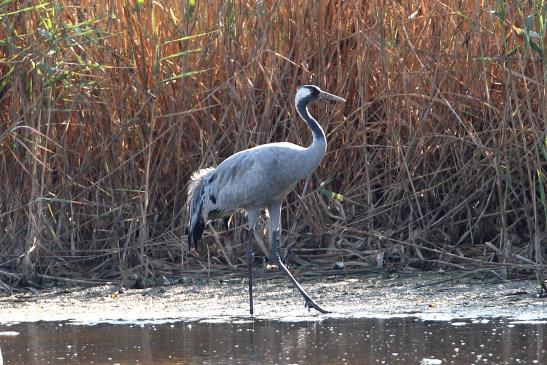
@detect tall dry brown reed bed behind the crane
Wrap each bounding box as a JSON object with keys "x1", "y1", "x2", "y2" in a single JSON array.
[{"x1": 0, "y1": 0, "x2": 547, "y2": 288}]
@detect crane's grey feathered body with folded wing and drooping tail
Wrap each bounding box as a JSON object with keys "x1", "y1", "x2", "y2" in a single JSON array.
[{"x1": 188, "y1": 143, "x2": 303, "y2": 249}]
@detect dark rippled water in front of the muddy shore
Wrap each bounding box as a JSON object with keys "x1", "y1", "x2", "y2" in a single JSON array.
[{"x1": 0, "y1": 318, "x2": 547, "y2": 364}]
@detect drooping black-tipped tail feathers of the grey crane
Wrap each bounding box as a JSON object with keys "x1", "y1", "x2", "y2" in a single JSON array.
[{"x1": 186, "y1": 168, "x2": 215, "y2": 249}]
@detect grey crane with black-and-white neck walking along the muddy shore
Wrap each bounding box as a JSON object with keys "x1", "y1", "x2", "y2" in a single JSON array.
[{"x1": 187, "y1": 85, "x2": 345, "y2": 316}]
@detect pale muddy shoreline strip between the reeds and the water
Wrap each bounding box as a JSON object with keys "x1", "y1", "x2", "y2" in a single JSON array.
[{"x1": 0, "y1": 272, "x2": 547, "y2": 325}]
